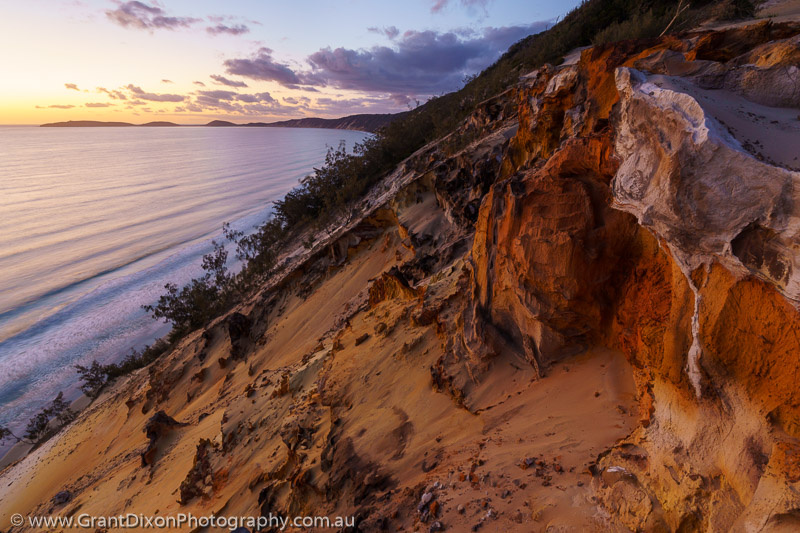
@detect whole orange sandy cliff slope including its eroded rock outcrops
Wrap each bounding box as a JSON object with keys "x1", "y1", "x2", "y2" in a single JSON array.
[{"x1": 0, "y1": 18, "x2": 800, "y2": 532}]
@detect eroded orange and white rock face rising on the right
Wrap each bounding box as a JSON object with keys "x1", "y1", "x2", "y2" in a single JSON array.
[{"x1": 456, "y1": 18, "x2": 800, "y2": 531}]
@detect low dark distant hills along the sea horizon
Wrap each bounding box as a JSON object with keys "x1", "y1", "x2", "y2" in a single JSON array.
[{"x1": 41, "y1": 113, "x2": 405, "y2": 133}]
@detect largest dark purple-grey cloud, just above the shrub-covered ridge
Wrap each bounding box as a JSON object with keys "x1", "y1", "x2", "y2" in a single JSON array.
[{"x1": 303, "y1": 22, "x2": 547, "y2": 95}]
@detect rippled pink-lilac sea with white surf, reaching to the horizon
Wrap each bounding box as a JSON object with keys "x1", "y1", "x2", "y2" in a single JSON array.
[{"x1": 0, "y1": 126, "x2": 366, "y2": 436}]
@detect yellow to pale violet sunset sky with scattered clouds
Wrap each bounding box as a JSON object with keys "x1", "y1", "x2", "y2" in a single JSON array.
[{"x1": 0, "y1": 0, "x2": 579, "y2": 124}]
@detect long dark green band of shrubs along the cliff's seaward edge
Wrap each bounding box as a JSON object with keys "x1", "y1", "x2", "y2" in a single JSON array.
[{"x1": 133, "y1": 0, "x2": 748, "y2": 374}]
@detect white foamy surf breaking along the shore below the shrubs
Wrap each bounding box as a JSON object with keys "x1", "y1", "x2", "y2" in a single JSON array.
[{"x1": 0, "y1": 127, "x2": 362, "y2": 457}]
